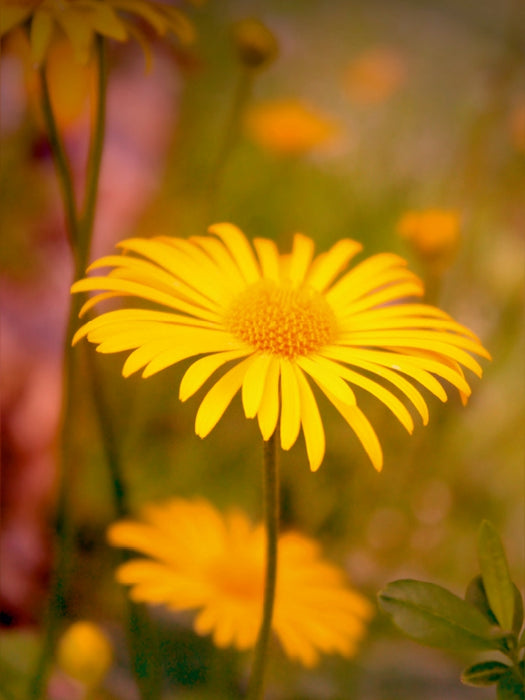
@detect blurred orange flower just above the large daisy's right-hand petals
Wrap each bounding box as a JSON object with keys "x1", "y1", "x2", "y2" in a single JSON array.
[{"x1": 397, "y1": 209, "x2": 460, "y2": 272}]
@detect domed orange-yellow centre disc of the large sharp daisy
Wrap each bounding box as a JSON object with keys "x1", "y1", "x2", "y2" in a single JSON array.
[{"x1": 226, "y1": 280, "x2": 336, "y2": 359}]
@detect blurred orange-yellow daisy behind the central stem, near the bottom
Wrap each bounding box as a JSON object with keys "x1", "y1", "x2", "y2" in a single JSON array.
[{"x1": 109, "y1": 499, "x2": 372, "y2": 666}]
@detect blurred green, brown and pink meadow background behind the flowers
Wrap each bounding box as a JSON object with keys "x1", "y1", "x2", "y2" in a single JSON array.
[{"x1": 0, "y1": 0, "x2": 525, "y2": 700}]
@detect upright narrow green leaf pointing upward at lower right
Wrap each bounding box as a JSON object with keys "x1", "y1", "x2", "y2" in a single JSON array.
[{"x1": 478, "y1": 520, "x2": 514, "y2": 631}]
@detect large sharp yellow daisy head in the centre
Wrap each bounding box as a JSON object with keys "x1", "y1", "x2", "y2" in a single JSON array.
[{"x1": 72, "y1": 223, "x2": 489, "y2": 470}]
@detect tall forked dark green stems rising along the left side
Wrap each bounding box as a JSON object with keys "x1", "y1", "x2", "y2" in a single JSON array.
[{"x1": 28, "y1": 36, "x2": 161, "y2": 700}]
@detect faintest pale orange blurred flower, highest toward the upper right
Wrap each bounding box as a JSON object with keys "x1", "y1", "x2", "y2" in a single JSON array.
[{"x1": 344, "y1": 46, "x2": 406, "y2": 104}]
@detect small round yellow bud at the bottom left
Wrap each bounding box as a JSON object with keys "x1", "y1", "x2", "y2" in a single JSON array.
[{"x1": 57, "y1": 621, "x2": 113, "y2": 688}]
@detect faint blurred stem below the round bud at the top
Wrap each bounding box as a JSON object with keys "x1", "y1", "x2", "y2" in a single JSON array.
[{"x1": 206, "y1": 67, "x2": 254, "y2": 219}]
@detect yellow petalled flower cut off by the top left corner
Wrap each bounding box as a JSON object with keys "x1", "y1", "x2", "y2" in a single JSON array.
[{"x1": 0, "y1": 0, "x2": 193, "y2": 65}]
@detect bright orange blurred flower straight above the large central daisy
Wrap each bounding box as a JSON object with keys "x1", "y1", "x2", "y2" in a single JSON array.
[{"x1": 245, "y1": 99, "x2": 339, "y2": 155}]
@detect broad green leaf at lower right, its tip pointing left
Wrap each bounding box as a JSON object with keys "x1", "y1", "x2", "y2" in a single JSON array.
[{"x1": 379, "y1": 579, "x2": 502, "y2": 650}]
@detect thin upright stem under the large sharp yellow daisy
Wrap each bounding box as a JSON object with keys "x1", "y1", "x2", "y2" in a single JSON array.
[{"x1": 246, "y1": 430, "x2": 279, "y2": 700}]
